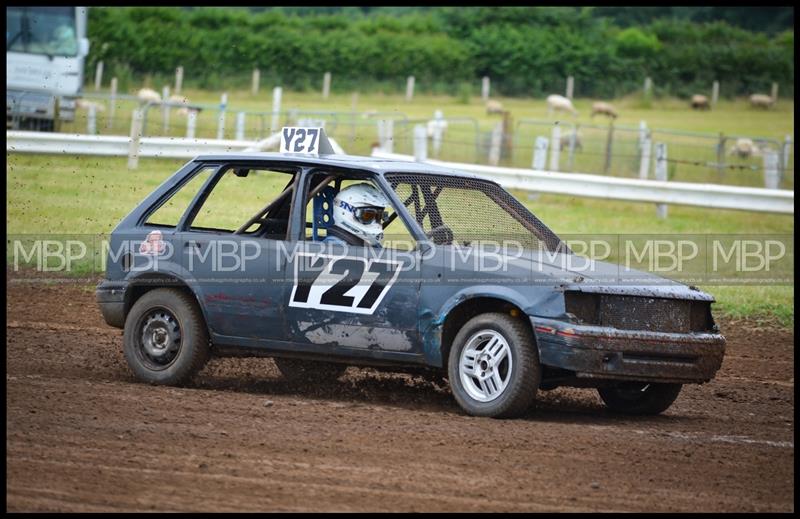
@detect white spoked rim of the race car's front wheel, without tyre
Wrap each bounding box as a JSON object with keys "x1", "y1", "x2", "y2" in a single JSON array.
[{"x1": 458, "y1": 330, "x2": 513, "y2": 402}]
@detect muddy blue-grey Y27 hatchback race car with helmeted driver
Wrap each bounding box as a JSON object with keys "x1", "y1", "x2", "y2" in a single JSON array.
[{"x1": 96, "y1": 129, "x2": 725, "y2": 417}]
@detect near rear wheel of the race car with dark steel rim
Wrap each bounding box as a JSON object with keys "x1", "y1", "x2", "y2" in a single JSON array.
[{"x1": 123, "y1": 288, "x2": 210, "y2": 385}]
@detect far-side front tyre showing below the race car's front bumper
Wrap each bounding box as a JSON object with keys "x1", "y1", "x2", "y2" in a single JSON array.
[{"x1": 597, "y1": 382, "x2": 683, "y2": 415}]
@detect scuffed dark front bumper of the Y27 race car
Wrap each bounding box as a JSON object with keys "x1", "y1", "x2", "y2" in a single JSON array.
[{"x1": 531, "y1": 317, "x2": 725, "y2": 383}]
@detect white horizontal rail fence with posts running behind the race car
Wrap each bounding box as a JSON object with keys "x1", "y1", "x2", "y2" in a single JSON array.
[{"x1": 6, "y1": 131, "x2": 794, "y2": 216}]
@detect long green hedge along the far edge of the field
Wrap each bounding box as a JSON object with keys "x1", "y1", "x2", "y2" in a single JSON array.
[{"x1": 87, "y1": 7, "x2": 794, "y2": 97}]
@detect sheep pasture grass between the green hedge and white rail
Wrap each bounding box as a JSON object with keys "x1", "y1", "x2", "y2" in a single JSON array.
[{"x1": 64, "y1": 87, "x2": 794, "y2": 189}]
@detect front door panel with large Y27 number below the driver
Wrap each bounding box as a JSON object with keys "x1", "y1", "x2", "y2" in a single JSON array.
[{"x1": 284, "y1": 173, "x2": 421, "y2": 357}]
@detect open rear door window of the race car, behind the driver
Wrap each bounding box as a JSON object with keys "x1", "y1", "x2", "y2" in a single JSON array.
[{"x1": 190, "y1": 166, "x2": 297, "y2": 240}]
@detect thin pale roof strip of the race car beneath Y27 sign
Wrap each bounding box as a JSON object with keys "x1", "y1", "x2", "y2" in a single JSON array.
[{"x1": 194, "y1": 152, "x2": 497, "y2": 184}]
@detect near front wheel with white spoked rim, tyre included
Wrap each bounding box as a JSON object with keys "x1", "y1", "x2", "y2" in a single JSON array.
[{"x1": 448, "y1": 313, "x2": 542, "y2": 418}]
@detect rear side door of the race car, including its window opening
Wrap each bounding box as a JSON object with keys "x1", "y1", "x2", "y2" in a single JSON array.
[{"x1": 180, "y1": 160, "x2": 296, "y2": 346}]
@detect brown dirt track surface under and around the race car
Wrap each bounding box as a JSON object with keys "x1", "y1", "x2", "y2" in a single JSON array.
[{"x1": 6, "y1": 276, "x2": 794, "y2": 511}]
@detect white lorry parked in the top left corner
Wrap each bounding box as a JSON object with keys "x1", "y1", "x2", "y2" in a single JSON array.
[{"x1": 6, "y1": 6, "x2": 89, "y2": 131}]
